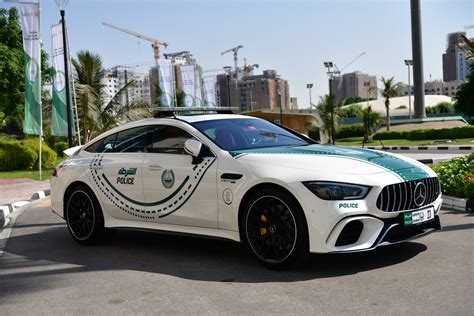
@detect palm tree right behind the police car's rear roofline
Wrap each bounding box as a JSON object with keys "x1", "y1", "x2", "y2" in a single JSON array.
[{"x1": 72, "y1": 51, "x2": 151, "y2": 143}]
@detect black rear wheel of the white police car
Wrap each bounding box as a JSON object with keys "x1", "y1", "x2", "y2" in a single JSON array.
[{"x1": 64, "y1": 186, "x2": 104, "y2": 245}]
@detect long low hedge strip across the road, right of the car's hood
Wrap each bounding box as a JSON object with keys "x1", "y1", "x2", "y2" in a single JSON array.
[{"x1": 374, "y1": 126, "x2": 474, "y2": 140}]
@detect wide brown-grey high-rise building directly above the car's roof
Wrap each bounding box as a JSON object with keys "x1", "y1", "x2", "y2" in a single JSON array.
[{"x1": 217, "y1": 70, "x2": 290, "y2": 112}]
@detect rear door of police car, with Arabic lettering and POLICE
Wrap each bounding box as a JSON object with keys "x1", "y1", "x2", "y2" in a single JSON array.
[{"x1": 91, "y1": 126, "x2": 149, "y2": 221}]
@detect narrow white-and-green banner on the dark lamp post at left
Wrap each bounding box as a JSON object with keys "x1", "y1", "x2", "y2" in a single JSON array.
[{"x1": 51, "y1": 23, "x2": 68, "y2": 136}]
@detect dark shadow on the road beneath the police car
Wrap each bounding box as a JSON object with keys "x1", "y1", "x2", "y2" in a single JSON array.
[{"x1": 1, "y1": 225, "x2": 427, "y2": 288}]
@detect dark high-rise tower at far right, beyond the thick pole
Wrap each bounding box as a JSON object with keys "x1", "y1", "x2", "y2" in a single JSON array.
[{"x1": 443, "y1": 32, "x2": 470, "y2": 82}]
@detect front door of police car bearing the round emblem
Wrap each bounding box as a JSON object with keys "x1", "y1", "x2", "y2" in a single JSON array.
[{"x1": 143, "y1": 125, "x2": 218, "y2": 228}]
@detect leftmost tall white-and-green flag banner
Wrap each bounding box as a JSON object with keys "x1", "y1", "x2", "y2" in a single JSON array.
[{"x1": 21, "y1": 3, "x2": 42, "y2": 135}]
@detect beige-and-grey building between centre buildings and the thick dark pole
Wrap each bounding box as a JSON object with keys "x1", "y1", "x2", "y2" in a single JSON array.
[{"x1": 331, "y1": 71, "x2": 377, "y2": 104}]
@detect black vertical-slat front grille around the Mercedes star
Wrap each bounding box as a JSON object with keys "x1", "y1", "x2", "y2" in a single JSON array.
[{"x1": 377, "y1": 177, "x2": 441, "y2": 212}]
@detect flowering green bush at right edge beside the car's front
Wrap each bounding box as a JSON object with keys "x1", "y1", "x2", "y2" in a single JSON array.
[{"x1": 433, "y1": 154, "x2": 474, "y2": 199}]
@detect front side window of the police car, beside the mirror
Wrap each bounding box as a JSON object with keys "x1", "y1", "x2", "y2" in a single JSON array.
[{"x1": 147, "y1": 125, "x2": 193, "y2": 154}]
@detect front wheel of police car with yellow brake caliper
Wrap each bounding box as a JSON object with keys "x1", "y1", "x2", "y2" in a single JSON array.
[{"x1": 241, "y1": 188, "x2": 309, "y2": 270}]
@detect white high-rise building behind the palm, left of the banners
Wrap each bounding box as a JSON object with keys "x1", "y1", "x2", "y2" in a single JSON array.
[{"x1": 102, "y1": 66, "x2": 150, "y2": 104}]
